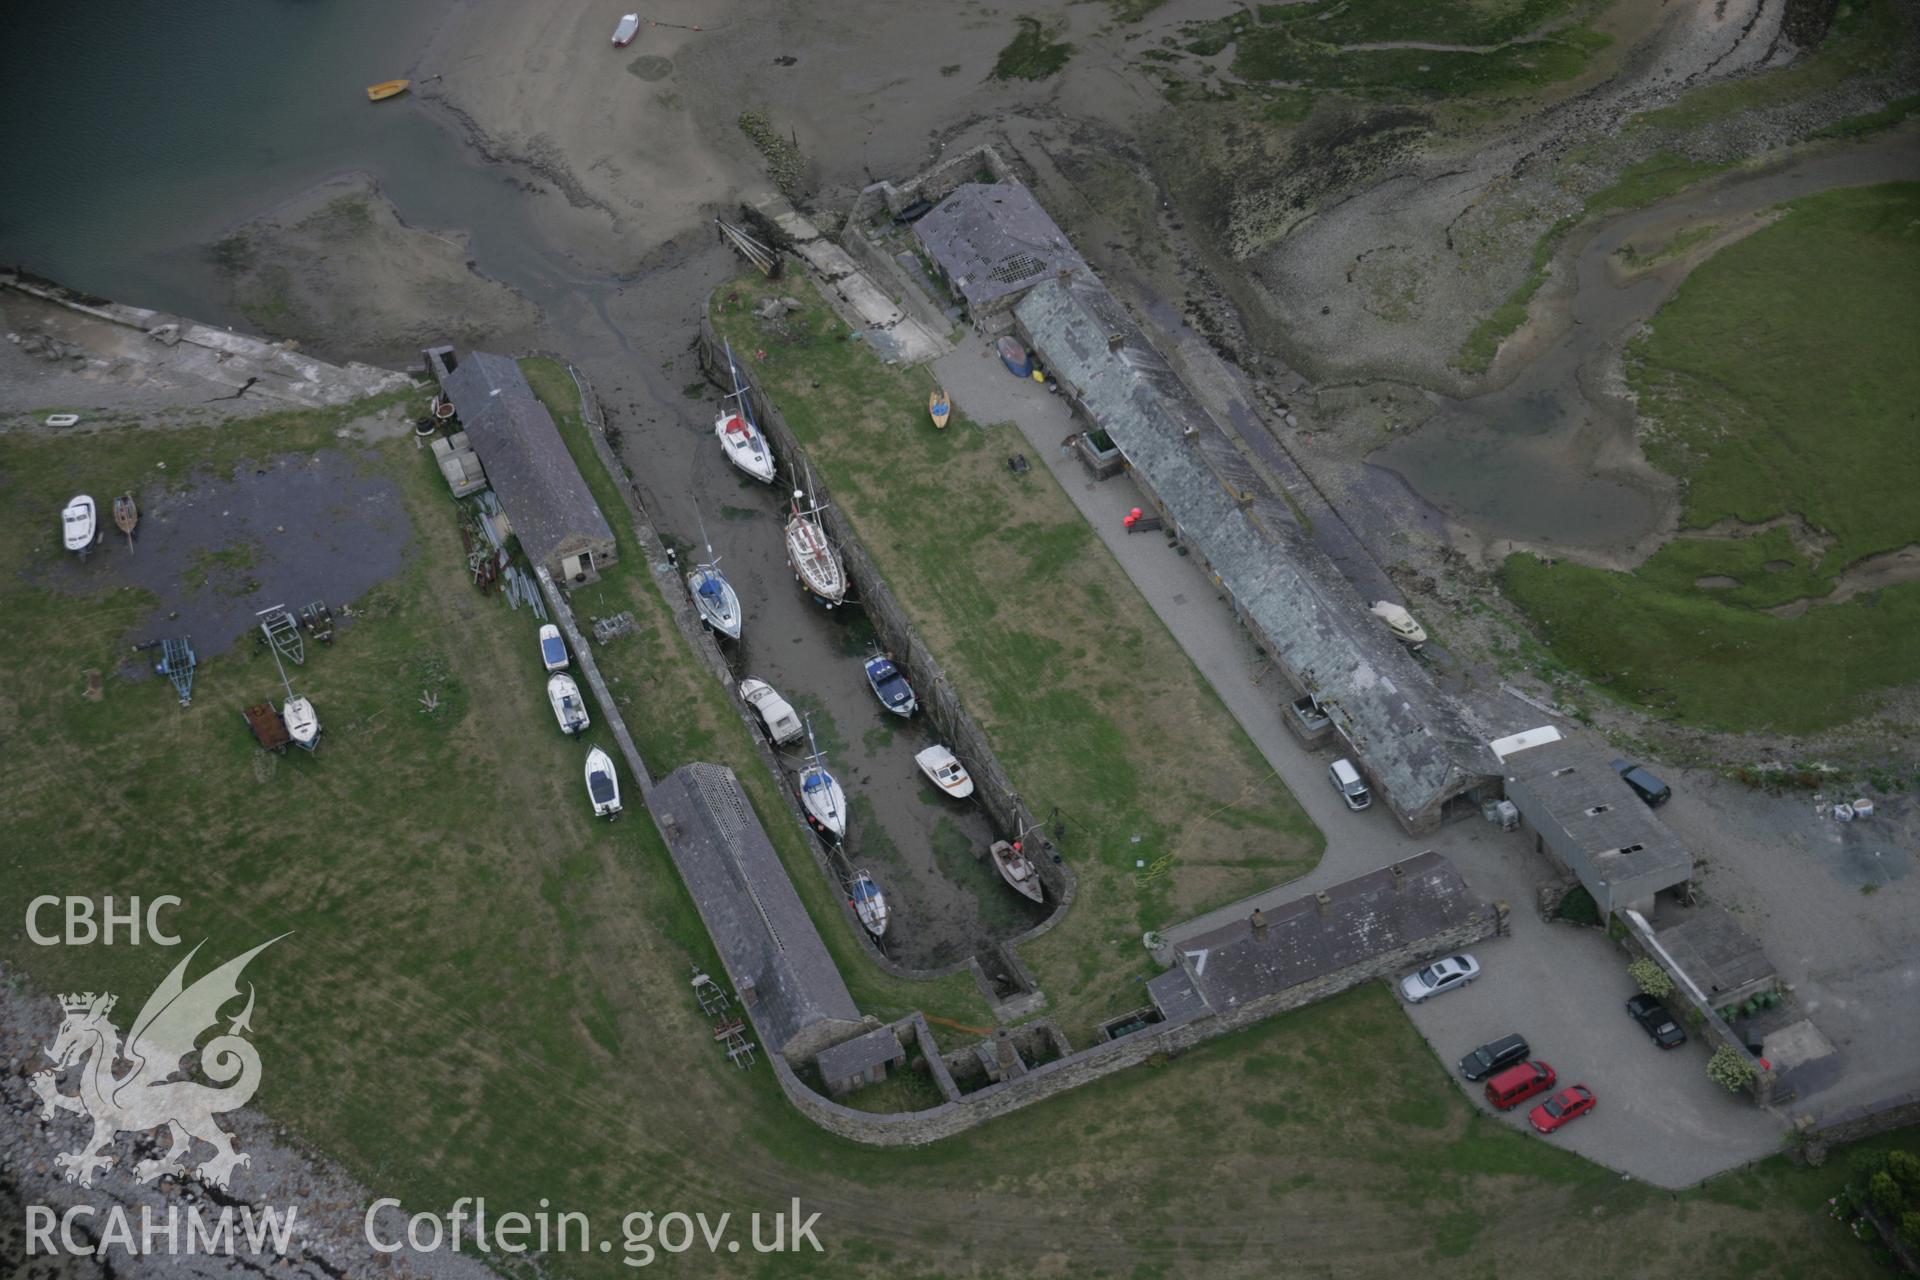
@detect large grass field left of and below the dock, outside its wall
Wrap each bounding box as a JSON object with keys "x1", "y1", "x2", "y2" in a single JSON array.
[{"x1": 0, "y1": 395, "x2": 1912, "y2": 1280}]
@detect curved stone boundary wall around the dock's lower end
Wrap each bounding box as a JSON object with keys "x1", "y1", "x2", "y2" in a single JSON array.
[{"x1": 770, "y1": 910, "x2": 1494, "y2": 1146}]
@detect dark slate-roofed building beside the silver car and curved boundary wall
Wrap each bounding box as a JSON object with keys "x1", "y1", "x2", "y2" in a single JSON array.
[{"x1": 1148, "y1": 852, "x2": 1492, "y2": 1023}]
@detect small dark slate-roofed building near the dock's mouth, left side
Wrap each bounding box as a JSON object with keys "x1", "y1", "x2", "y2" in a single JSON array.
[{"x1": 424, "y1": 347, "x2": 618, "y2": 585}]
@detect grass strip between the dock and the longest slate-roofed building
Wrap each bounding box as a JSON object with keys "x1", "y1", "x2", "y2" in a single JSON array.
[{"x1": 712, "y1": 276, "x2": 1325, "y2": 1044}]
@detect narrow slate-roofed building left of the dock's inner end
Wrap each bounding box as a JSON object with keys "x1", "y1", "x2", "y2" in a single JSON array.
[{"x1": 647, "y1": 764, "x2": 877, "y2": 1075}]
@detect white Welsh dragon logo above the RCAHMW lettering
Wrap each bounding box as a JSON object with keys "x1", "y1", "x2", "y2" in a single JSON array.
[{"x1": 33, "y1": 933, "x2": 286, "y2": 1188}]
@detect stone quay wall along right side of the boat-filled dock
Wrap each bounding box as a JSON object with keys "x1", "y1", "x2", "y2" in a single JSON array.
[{"x1": 697, "y1": 319, "x2": 1077, "y2": 940}]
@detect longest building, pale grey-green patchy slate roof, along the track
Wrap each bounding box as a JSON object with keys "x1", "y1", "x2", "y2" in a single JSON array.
[{"x1": 1014, "y1": 274, "x2": 1500, "y2": 833}]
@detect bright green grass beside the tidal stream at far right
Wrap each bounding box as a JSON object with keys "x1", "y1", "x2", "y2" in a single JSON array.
[{"x1": 1503, "y1": 182, "x2": 1920, "y2": 731}]
